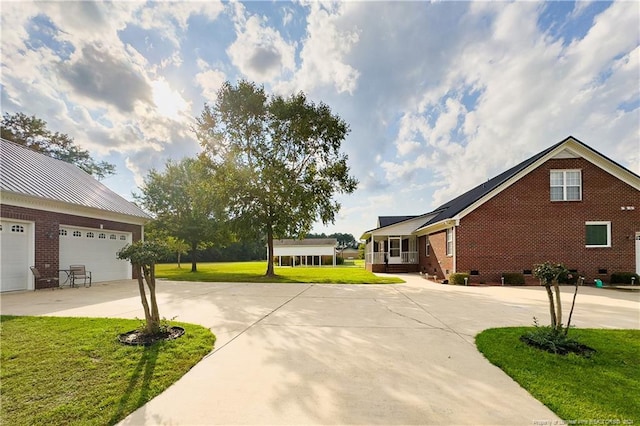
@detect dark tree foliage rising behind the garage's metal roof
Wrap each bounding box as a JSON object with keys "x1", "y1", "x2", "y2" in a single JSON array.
[{"x1": 0, "y1": 112, "x2": 116, "y2": 179}]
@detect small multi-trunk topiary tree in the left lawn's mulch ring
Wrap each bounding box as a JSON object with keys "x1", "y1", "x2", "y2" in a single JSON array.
[{"x1": 116, "y1": 241, "x2": 169, "y2": 335}]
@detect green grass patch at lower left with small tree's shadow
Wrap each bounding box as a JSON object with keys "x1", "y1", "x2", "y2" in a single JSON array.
[{"x1": 0, "y1": 315, "x2": 215, "y2": 426}]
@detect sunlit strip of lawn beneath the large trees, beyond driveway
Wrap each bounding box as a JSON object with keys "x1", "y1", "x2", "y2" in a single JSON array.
[{"x1": 156, "y1": 261, "x2": 404, "y2": 284}]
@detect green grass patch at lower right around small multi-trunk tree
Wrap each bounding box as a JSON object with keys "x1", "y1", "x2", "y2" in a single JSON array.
[{"x1": 476, "y1": 327, "x2": 640, "y2": 424}]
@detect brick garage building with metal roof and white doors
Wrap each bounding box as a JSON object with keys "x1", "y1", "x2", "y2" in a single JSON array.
[{"x1": 0, "y1": 139, "x2": 151, "y2": 291}]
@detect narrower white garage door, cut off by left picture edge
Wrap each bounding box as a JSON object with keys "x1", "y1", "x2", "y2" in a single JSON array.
[{"x1": 0, "y1": 220, "x2": 34, "y2": 291}]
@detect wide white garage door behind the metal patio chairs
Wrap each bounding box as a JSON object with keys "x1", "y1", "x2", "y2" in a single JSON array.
[{"x1": 60, "y1": 225, "x2": 132, "y2": 282}]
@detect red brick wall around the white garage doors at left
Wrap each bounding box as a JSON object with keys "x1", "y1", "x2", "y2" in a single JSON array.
[{"x1": 0, "y1": 204, "x2": 142, "y2": 288}]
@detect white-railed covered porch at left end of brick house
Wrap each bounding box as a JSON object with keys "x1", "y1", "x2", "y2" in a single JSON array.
[{"x1": 365, "y1": 234, "x2": 418, "y2": 273}]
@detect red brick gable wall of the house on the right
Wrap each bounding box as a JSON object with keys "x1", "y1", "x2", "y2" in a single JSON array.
[{"x1": 456, "y1": 159, "x2": 640, "y2": 282}]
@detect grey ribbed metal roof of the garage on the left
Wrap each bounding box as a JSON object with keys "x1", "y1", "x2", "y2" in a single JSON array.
[{"x1": 0, "y1": 139, "x2": 150, "y2": 219}]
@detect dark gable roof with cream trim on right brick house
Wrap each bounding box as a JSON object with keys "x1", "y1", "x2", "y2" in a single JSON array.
[{"x1": 418, "y1": 136, "x2": 640, "y2": 233}]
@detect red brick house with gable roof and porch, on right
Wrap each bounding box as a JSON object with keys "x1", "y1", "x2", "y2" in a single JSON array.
[{"x1": 361, "y1": 136, "x2": 640, "y2": 282}]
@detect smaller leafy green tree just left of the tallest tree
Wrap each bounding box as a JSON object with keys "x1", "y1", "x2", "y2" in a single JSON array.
[{"x1": 135, "y1": 155, "x2": 228, "y2": 272}]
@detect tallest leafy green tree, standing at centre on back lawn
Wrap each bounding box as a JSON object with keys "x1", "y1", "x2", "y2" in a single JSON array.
[{"x1": 195, "y1": 81, "x2": 357, "y2": 276}]
